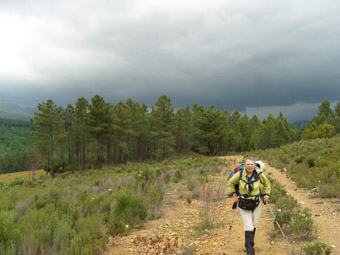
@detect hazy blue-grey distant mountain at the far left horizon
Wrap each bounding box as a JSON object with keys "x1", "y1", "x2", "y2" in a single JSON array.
[{"x1": 0, "y1": 103, "x2": 37, "y2": 120}]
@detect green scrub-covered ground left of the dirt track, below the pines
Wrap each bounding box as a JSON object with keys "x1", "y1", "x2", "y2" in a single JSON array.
[{"x1": 0, "y1": 154, "x2": 223, "y2": 255}]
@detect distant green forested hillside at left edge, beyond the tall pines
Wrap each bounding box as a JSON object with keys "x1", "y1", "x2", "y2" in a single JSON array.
[{"x1": 0, "y1": 119, "x2": 36, "y2": 173}]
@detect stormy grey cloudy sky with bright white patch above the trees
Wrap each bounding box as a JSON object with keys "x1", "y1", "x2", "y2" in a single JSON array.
[{"x1": 0, "y1": 0, "x2": 340, "y2": 121}]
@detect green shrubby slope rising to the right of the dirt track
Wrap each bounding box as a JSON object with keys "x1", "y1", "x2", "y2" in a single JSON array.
[{"x1": 254, "y1": 137, "x2": 340, "y2": 197}]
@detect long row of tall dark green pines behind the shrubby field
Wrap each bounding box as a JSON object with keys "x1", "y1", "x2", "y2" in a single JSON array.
[{"x1": 32, "y1": 94, "x2": 300, "y2": 175}]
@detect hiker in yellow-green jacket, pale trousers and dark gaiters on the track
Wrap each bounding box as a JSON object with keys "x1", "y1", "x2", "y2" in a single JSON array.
[{"x1": 228, "y1": 157, "x2": 270, "y2": 255}]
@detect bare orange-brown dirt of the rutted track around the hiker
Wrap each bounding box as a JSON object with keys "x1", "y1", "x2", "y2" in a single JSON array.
[{"x1": 104, "y1": 156, "x2": 340, "y2": 255}]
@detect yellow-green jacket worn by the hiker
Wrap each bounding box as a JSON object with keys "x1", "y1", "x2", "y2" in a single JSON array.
[{"x1": 228, "y1": 167, "x2": 270, "y2": 199}]
